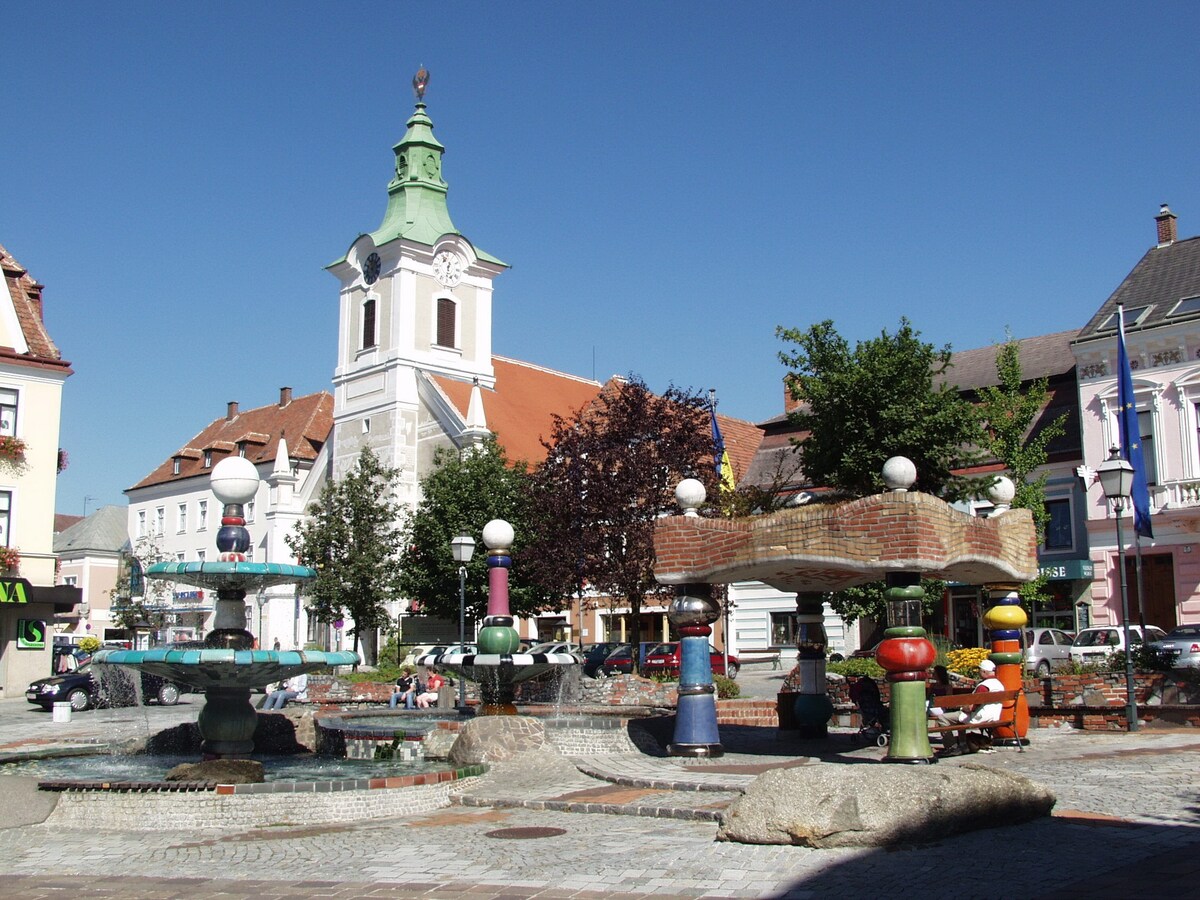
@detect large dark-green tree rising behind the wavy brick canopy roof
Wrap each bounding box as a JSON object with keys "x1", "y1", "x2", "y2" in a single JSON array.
[{"x1": 775, "y1": 319, "x2": 979, "y2": 500}]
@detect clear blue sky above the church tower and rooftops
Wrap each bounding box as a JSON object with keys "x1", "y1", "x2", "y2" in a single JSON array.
[{"x1": 7, "y1": 0, "x2": 1200, "y2": 514}]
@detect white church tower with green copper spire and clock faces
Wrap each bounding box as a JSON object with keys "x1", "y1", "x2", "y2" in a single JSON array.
[{"x1": 328, "y1": 68, "x2": 508, "y2": 503}]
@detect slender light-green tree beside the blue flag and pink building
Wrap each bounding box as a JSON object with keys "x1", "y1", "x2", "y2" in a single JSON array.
[{"x1": 976, "y1": 340, "x2": 1067, "y2": 608}]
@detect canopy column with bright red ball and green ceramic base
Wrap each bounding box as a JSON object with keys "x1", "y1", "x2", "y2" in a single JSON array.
[{"x1": 875, "y1": 572, "x2": 937, "y2": 762}]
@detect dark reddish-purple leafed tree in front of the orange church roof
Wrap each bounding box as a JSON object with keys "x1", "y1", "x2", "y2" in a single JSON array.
[{"x1": 530, "y1": 376, "x2": 716, "y2": 666}]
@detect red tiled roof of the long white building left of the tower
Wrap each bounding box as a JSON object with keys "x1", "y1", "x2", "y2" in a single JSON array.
[{"x1": 128, "y1": 391, "x2": 334, "y2": 491}]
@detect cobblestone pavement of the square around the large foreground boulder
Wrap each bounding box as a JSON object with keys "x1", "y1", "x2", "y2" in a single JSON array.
[{"x1": 0, "y1": 696, "x2": 1200, "y2": 900}]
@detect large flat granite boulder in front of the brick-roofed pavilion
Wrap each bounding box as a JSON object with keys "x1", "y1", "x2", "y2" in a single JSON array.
[{"x1": 716, "y1": 763, "x2": 1055, "y2": 847}]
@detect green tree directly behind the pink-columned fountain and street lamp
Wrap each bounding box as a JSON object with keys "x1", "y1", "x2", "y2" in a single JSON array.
[{"x1": 400, "y1": 439, "x2": 560, "y2": 634}]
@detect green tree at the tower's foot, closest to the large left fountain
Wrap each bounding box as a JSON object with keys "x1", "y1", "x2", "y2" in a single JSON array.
[{"x1": 287, "y1": 446, "x2": 402, "y2": 661}]
